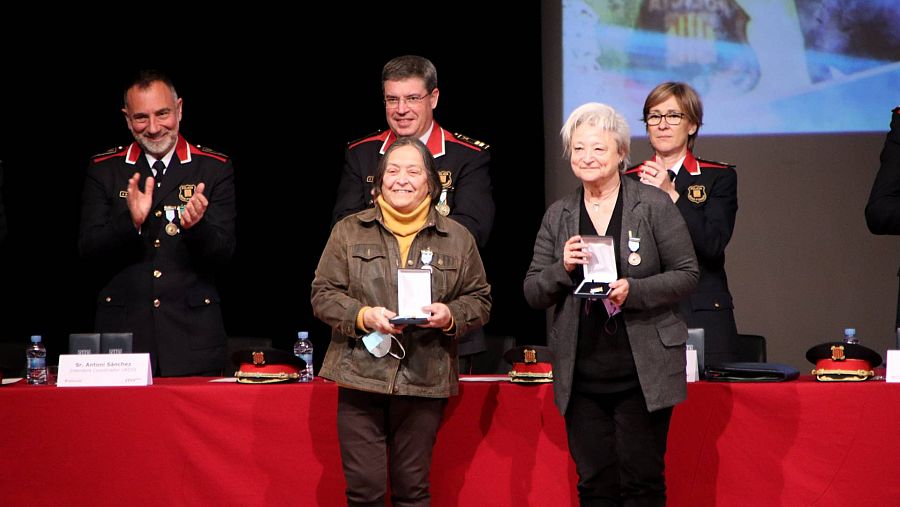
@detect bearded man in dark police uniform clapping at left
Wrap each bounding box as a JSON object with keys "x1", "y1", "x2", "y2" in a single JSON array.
[{"x1": 79, "y1": 71, "x2": 235, "y2": 376}]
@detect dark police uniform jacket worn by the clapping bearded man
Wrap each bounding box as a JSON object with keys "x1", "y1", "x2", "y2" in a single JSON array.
[{"x1": 79, "y1": 135, "x2": 235, "y2": 376}]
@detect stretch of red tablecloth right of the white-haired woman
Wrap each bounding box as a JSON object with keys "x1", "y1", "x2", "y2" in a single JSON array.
[{"x1": 666, "y1": 376, "x2": 900, "y2": 507}]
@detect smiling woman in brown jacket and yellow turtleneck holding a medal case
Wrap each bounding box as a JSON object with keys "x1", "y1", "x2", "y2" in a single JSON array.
[{"x1": 312, "y1": 137, "x2": 491, "y2": 506}]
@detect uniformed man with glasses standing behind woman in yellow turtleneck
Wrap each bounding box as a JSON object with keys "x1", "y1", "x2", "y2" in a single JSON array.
[{"x1": 332, "y1": 56, "x2": 494, "y2": 373}]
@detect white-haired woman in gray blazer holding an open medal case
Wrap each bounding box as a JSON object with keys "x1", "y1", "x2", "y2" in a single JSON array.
[{"x1": 524, "y1": 103, "x2": 698, "y2": 506}]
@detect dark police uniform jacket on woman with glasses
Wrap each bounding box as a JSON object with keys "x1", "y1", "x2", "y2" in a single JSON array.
[{"x1": 628, "y1": 150, "x2": 739, "y2": 364}]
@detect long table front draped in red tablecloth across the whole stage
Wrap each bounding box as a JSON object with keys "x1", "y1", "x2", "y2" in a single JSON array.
[{"x1": 0, "y1": 378, "x2": 900, "y2": 507}]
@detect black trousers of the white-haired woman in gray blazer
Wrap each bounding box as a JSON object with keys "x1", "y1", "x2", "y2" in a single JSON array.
[{"x1": 566, "y1": 388, "x2": 672, "y2": 507}]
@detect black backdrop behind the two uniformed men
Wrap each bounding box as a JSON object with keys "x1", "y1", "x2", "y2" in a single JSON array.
[{"x1": 0, "y1": 3, "x2": 544, "y2": 374}]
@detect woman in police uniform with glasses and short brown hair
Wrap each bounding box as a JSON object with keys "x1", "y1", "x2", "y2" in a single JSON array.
[{"x1": 628, "y1": 82, "x2": 741, "y2": 370}]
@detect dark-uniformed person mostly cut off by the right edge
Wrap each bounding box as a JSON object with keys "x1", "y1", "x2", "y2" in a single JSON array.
[{"x1": 866, "y1": 106, "x2": 900, "y2": 328}]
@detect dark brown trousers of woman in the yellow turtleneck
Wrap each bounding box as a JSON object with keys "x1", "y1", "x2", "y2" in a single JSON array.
[{"x1": 337, "y1": 387, "x2": 446, "y2": 507}]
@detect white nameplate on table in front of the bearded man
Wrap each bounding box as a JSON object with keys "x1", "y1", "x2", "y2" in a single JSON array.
[{"x1": 56, "y1": 353, "x2": 153, "y2": 387}]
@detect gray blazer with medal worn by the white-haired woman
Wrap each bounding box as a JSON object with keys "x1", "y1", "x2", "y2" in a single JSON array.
[{"x1": 524, "y1": 177, "x2": 699, "y2": 415}]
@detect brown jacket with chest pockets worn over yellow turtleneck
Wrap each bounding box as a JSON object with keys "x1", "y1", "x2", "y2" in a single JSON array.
[{"x1": 312, "y1": 207, "x2": 491, "y2": 398}]
